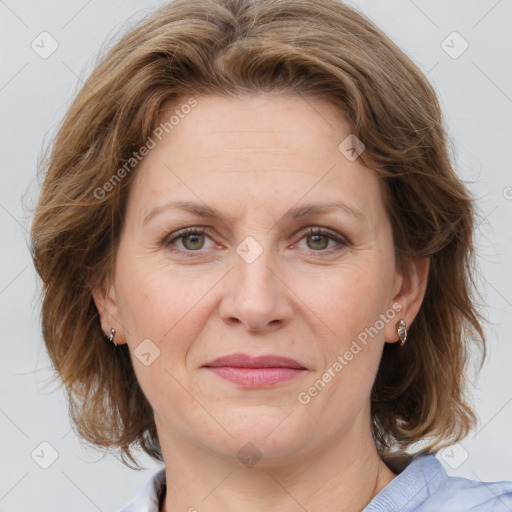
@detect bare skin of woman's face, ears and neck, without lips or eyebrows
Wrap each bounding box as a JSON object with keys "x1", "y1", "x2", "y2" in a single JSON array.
[{"x1": 94, "y1": 93, "x2": 428, "y2": 512}]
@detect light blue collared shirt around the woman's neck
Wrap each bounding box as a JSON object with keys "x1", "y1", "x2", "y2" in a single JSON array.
[{"x1": 121, "y1": 452, "x2": 512, "y2": 512}]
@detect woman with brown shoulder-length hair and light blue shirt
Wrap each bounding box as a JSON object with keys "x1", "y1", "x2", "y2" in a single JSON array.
[{"x1": 32, "y1": 0, "x2": 512, "y2": 512}]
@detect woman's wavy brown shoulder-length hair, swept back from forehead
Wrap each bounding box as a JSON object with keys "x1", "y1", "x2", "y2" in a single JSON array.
[{"x1": 31, "y1": 0, "x2": 485, "y2": 467}]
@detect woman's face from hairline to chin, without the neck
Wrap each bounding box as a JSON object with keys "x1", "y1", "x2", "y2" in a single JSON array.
[{"x1": 95, "y1": 94, "x2": 420, "y2": 463}]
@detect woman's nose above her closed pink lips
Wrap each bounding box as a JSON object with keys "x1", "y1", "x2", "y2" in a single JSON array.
[{"x1": 219, "y1": 242, "x2": 293, "y2": 332}]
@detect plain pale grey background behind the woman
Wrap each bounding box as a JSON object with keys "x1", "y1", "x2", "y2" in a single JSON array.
[{"x1": 0, "y1": 0, "x2": 512, "y2": 512}]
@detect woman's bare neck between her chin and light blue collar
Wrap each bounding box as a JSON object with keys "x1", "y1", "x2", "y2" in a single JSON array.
[{"x1": 157, "y1": 410, "x2": 396, "y2": 512}]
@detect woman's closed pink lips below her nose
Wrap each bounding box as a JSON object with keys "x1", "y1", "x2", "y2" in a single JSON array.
[{"x1": 204, "y1": 354, "x2": 307, "y2": 388}]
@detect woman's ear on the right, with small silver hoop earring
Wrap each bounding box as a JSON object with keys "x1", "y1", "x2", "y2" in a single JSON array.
[{"x1": 385, "y1": 258, "x2": 430, "y2": 343}]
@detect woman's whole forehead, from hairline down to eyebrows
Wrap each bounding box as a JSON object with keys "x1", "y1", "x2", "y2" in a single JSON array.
[{"x1": 127, "y1": 94, "x2": 381, "y2": 224}]
